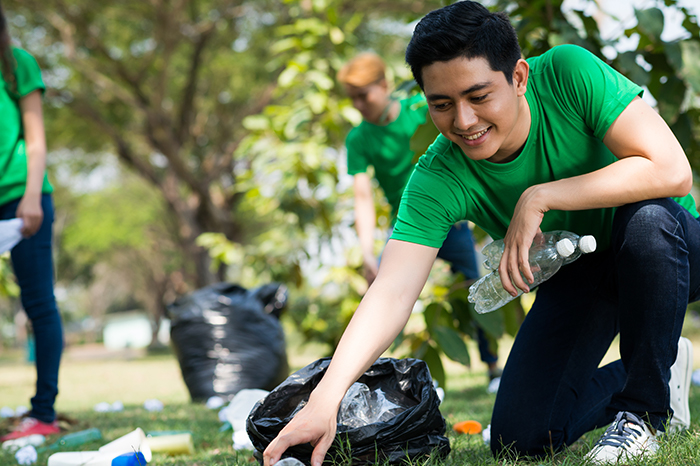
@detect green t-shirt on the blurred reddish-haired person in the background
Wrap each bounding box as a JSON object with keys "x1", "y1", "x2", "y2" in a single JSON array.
[{"x1": 345, "y1": 94, "x2": 428, "y2": 217}]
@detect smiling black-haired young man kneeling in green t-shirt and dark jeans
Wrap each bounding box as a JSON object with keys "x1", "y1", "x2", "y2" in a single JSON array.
[{"x1": 264, "y1": 1, "x2": 700, "y2": 466}]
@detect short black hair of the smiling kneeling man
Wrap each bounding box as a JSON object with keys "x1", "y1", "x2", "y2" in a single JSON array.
[{"x1": 406, "y1": 0, "x2": 521, "y2": 89}]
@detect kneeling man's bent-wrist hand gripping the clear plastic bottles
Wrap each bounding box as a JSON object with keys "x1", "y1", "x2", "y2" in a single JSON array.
[{"x1": 498, "y1": 185, "x2": 548, "y2": 296}]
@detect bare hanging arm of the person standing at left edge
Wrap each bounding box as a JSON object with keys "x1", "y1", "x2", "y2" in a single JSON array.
[{"x1": 15, "y1": 90, "x2": 46, "y2": 238}]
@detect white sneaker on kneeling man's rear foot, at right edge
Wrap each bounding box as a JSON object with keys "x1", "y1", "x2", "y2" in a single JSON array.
[{"x1": 668, "y1": 337, "x2": 693, "y2": 432}]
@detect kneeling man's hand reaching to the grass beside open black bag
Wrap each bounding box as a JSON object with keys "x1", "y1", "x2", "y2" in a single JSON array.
[{"x1": 263, "y1": 399, "x2": 338, "y2": 466}]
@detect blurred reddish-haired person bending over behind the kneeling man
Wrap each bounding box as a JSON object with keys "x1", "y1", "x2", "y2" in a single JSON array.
[{"x1": 338, "y1": 52, "x2": 501, "y2": 380}]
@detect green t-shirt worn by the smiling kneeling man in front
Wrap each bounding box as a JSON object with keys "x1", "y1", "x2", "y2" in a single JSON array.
[{"x1": 392, "y1": 45, "x2": 698, "y2": 250}]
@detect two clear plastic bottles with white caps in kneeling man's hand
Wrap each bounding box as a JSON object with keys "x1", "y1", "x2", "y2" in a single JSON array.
[{"x1": 469, "y1": 231, "x2": 596, "y2": 314}]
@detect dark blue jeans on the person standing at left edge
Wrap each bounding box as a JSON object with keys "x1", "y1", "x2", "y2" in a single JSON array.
[{"x1": 0, "y1": 194, "x2": 63, "y2": 422}]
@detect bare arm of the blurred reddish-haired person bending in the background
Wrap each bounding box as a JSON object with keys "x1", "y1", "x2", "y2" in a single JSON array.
[{"x1": 353, "y1": 173, "x2": 379, "y2": 285}]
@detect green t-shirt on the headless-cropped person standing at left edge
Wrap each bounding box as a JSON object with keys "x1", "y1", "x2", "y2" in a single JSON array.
[{"x1": 0, "y1": 48, "x2": 53, "y2": 205}]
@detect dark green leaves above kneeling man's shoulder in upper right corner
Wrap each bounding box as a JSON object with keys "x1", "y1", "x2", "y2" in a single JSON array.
[{"x1": 504, "y1": 0, "x2": 700, "y2": 167}]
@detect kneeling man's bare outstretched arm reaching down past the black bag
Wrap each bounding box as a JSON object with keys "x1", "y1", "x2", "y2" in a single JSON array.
[{"x1": 263, "y1": 240, "x2": 438, "y2": 466}]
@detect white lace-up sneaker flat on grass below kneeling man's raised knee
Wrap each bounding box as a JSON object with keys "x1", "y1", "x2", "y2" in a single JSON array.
[{"x1": 586, "y1": 411, "x2": 659, "y2": 464}]
